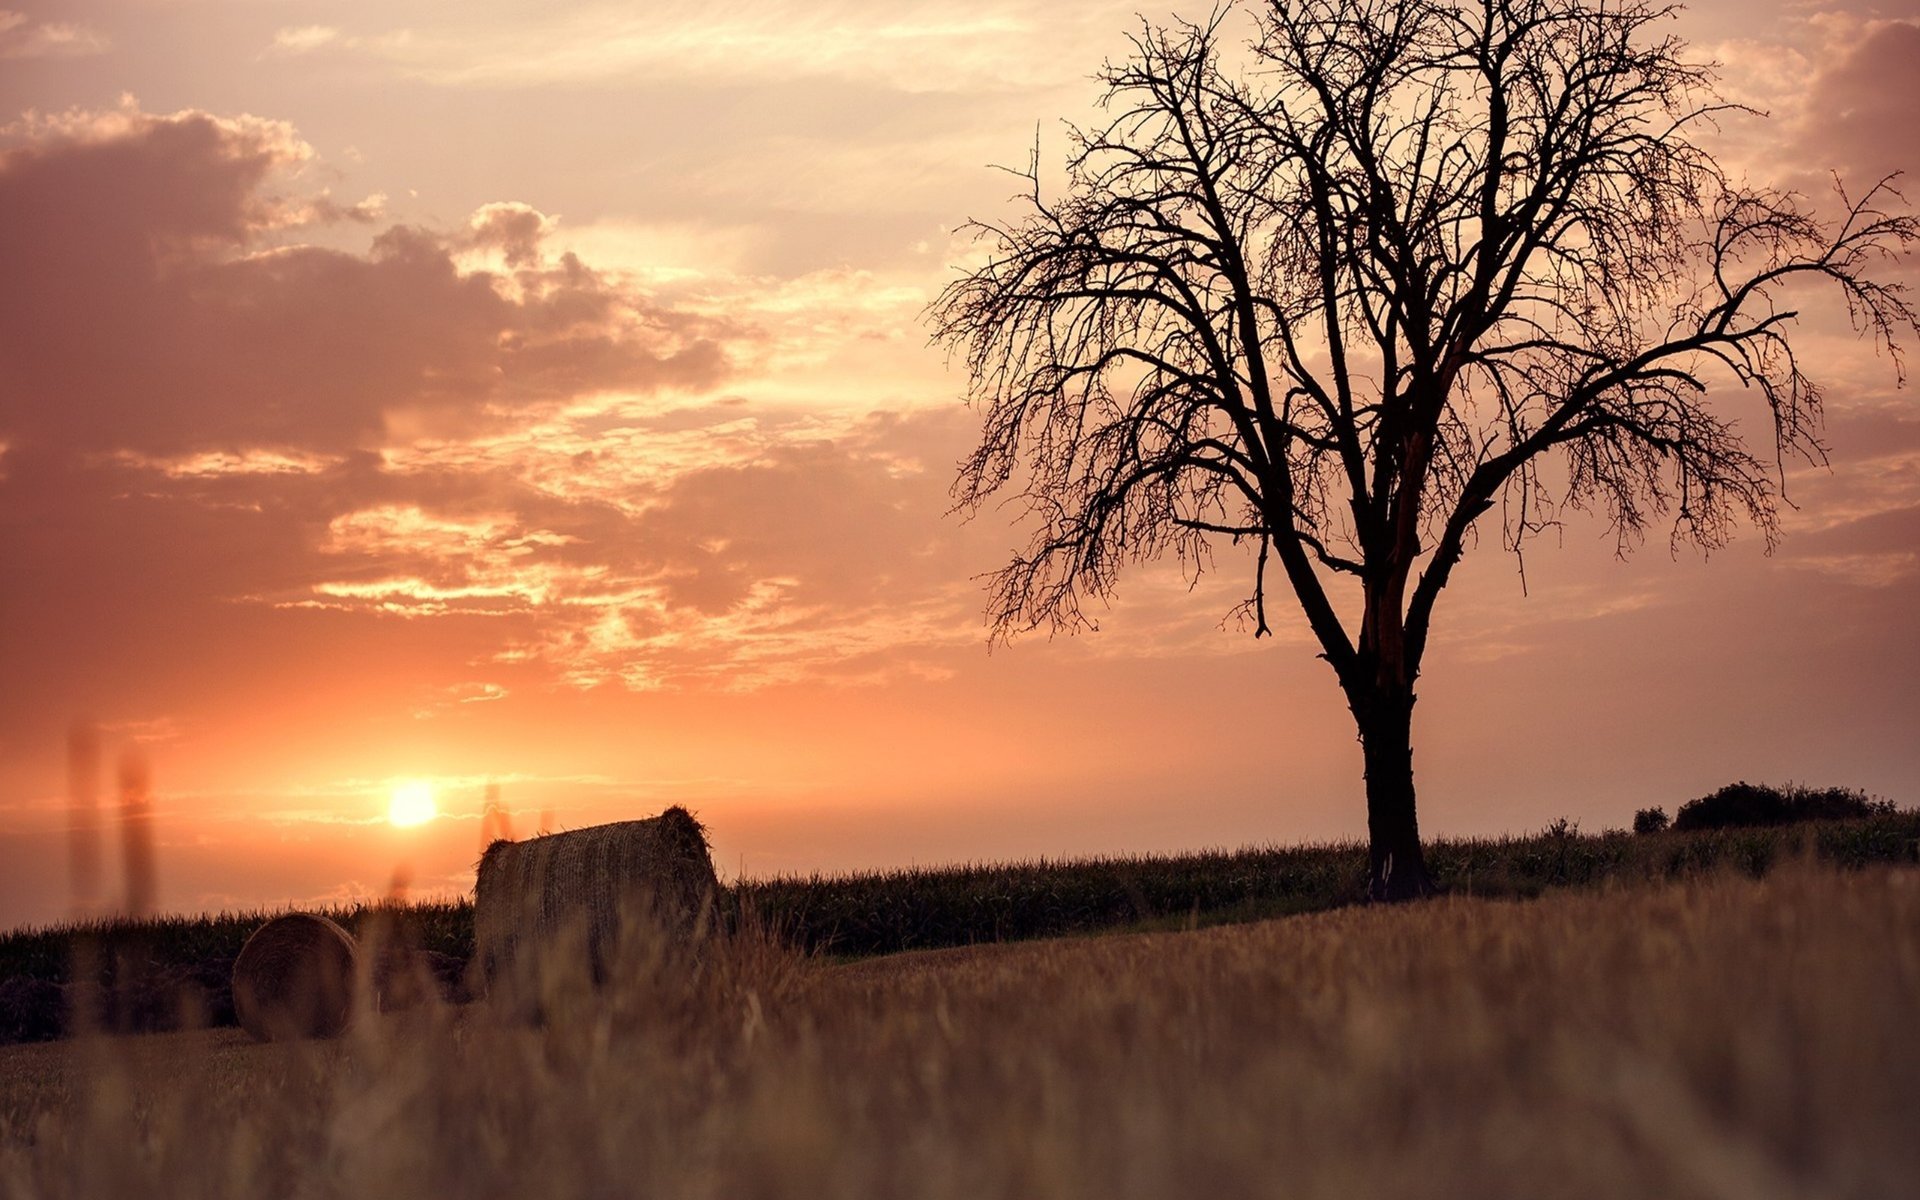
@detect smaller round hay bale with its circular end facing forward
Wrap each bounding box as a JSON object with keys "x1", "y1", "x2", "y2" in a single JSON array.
[{"x1": 234, "y1": 912, "x2": 359, "y2": 1043}]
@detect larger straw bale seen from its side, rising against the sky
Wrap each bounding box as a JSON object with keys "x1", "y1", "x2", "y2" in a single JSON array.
[{"x1": 474, "y1": 804, "x2": 720, "y2": 981}]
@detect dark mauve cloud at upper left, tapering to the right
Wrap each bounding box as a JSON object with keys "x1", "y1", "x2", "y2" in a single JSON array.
[{"x1": 0, "y1": 111, "x2": 732, "y2": 453}]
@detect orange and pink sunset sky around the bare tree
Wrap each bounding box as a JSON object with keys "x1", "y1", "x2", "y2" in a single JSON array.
[{"x1": 0, "y1": 0, "x2": 1920, "y2": 927}]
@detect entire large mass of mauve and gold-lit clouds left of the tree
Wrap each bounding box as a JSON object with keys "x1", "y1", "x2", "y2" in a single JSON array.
[{"x1": 0, "y1": 102, "x2": 979, "y2": 712}]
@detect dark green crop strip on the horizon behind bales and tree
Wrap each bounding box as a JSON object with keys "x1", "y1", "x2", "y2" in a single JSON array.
[{"x1": 0, "y1": 804, "x2": 1920, "y2": 1043}]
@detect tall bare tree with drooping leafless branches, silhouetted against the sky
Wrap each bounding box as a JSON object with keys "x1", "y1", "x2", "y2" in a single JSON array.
[{"x1": 931, "y1": 0, "x2": 1920, "y2": 899}]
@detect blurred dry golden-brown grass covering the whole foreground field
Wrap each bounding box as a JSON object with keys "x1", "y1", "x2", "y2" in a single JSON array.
[{"x1": 0, "y1": 866, "x2": 1920, "y2": 1200}]
